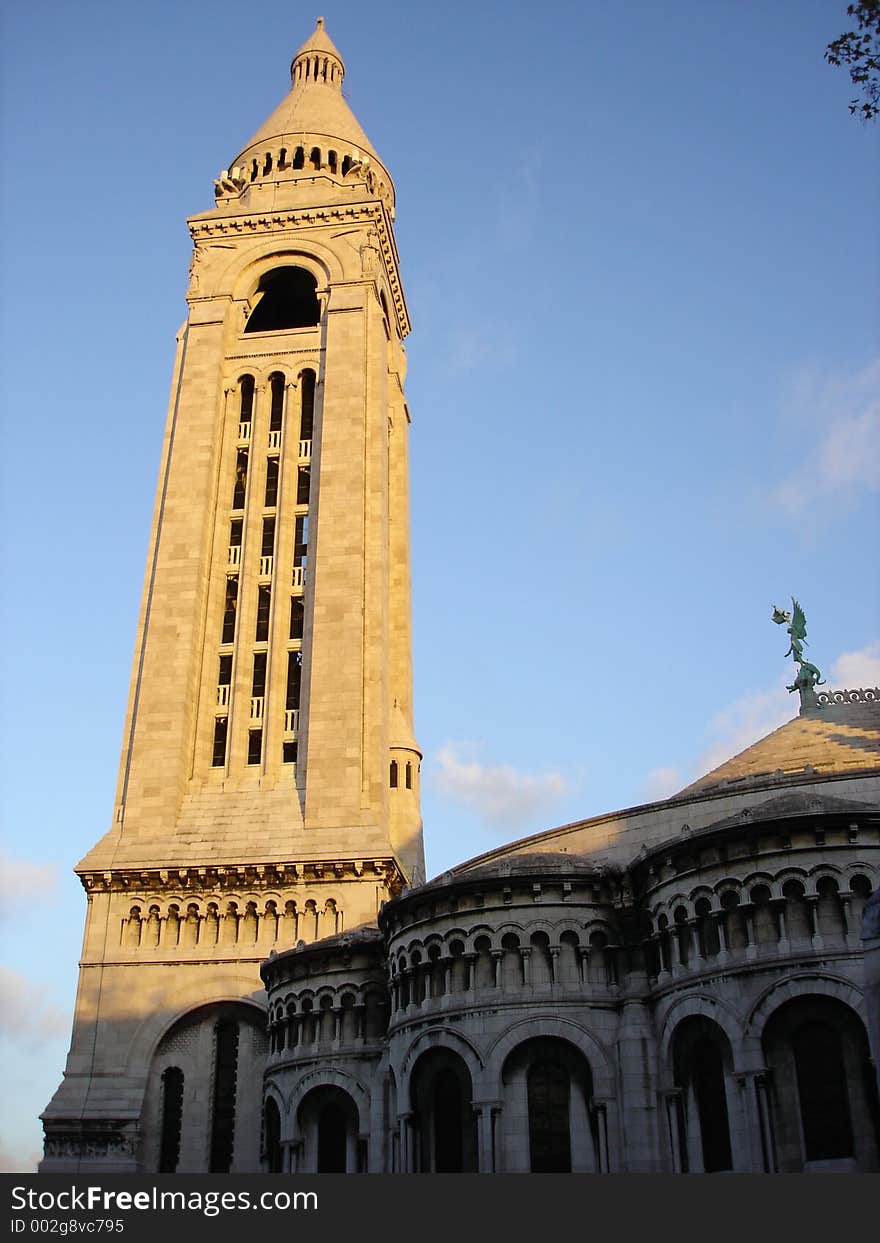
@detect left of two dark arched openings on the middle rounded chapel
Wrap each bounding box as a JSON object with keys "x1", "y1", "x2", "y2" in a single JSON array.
[{"x1": 410, "y1": 1049, "x2": 477, "y2": 1173}]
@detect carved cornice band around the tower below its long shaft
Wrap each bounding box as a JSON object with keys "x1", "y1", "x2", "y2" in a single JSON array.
[{"x1": 80, "y1": 858, "x2": 404, "y2": 894}]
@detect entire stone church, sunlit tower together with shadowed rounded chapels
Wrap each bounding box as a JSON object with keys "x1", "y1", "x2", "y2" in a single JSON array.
[{"x1": 42, "y1": 22, "x2": 880, "y2": 1173}]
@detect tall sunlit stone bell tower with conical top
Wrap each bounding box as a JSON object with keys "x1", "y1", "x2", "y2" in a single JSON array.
[{"x1": 41, "y1": 19, "x2": 424, "y2": 1172}]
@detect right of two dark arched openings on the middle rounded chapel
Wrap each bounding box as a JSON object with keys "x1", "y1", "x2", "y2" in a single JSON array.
[{"x1": 498, "y1": 1037, "x2": 600, "y2": 1173}]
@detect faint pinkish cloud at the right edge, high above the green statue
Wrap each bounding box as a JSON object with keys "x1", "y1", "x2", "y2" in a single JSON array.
[{"x1": 774, "y1": 359, "x2": 880, "y2": 516}]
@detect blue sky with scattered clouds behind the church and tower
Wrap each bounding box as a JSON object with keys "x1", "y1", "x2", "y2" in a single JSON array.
[{"x1": 0, "y1": 0, "x2": 880, "y2": 1168}]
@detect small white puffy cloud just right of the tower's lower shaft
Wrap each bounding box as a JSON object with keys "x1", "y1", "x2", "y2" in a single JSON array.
[{"x1": 434, "y1": 743, "x2": 568, "y2": 828}]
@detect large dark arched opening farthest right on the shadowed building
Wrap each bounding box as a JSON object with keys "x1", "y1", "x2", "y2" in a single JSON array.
[{"x1": 763, "y1": 996, "x2": 879, "y2": 1173}]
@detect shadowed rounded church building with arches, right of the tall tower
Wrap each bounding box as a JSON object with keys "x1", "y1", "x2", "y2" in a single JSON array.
[{"x1": 262, "y1": 692, "x2": 880, "y2": 1173}]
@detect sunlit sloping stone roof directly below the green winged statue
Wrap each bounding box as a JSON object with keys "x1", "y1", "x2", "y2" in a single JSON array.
[{"x1": 675, "y1": 691, "x2": 880, "y2": 798}]
